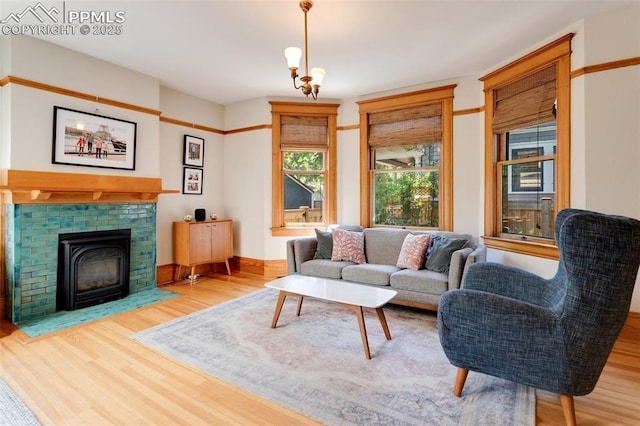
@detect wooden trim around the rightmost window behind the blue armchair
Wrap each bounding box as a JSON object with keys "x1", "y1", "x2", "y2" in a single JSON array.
[{"x1": 480, "y1": 33, "x2": 574, "y2": 259}]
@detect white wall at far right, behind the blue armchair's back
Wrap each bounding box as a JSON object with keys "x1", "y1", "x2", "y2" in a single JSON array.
[{"x1": 584, "y1": 5, "x2": 640, "y2": 312}]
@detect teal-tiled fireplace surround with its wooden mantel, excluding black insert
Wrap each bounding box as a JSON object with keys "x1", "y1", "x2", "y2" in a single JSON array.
[{"x1": 0, "y1": 169, "x2": 164, "y2": 324}]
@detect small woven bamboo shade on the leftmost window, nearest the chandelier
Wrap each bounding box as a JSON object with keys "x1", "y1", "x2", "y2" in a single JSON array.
[{"x1": 280, "y1": 115, "x2": 329, "y2": 151}]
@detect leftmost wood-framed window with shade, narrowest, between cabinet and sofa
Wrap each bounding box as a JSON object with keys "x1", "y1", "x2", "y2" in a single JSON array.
[{"x1": 271, "y1": 102, "x2": 338, "y2": 235}]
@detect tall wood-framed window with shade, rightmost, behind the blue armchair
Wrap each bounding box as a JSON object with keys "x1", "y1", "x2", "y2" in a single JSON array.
[{"x1": 480, "y1": 34, "x2": 572, "y2": 258}]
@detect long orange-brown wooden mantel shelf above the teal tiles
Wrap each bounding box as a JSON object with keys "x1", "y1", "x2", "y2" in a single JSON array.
[{"x1": 0, "y1": 169, "x2": 180, "y2": 204}]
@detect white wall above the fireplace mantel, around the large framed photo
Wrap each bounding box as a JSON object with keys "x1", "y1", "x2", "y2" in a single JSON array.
[{"x1": 0, "y1": 36, "x2": 159, "y2": 176}]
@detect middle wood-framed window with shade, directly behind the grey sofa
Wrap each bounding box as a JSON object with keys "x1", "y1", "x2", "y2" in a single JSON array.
[{"x1": 358, "y1": 85, "x2": 455, "y2": 229}]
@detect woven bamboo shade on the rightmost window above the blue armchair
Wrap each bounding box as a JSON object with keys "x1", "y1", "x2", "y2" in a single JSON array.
[{"x1": 492, "y1": 64, "x2": 556, "y2": 133}]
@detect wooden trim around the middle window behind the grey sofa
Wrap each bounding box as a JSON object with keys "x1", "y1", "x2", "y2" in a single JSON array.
[{"x1": 357, "y1": 84, "x2": 457, "y2": 231}]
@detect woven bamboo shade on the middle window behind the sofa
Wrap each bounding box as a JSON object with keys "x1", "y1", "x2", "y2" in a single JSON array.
[{"x1": 369, "y1": 103, "x2": 442, "y2": 148}]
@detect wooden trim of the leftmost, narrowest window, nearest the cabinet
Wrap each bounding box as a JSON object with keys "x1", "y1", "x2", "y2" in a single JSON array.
[{"x1": 269, "y1": 101, "x2": 340, "y2": 237}]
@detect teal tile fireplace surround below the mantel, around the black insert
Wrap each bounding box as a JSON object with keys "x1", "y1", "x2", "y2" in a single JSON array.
[{"x1": 4, "y1": 203, "x2": 156, "y2": 324}]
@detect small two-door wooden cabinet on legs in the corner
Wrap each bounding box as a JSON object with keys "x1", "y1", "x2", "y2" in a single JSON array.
[{"x1": 173, "y1": 219, "x2": 233, "y2": 284}]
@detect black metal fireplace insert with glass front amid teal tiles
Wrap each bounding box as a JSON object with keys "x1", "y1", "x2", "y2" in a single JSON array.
[{"x1": 56, "y1": 229, "x2": 131, "y2": 311}]
